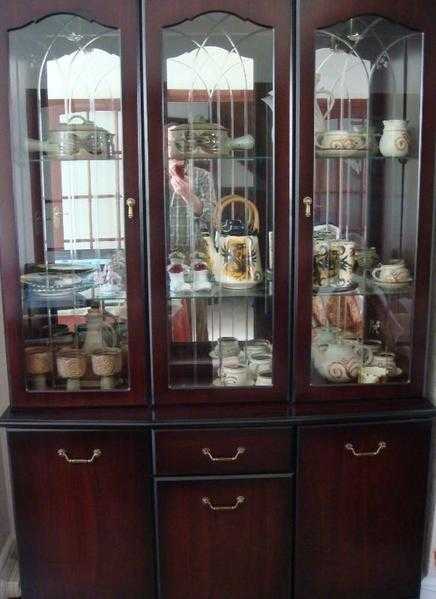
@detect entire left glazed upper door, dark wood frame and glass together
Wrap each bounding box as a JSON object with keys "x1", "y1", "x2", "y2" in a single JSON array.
[{"x1": 1, "y1": 1, "x2": 148, "y2": 405}]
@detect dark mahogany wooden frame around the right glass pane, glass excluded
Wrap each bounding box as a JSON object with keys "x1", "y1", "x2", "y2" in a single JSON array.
[{"x1": 293, "y1": 0, "x2": 436, "y2": 401}]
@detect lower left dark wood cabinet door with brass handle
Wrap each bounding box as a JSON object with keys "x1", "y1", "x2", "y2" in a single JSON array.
[{"x1": 8, "y1": 431, "x2": 154, "y2": 599}]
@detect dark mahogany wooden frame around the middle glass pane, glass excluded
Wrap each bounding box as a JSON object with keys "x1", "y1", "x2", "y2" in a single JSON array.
[{"x1": 144, "y1": 0, "x2": 292, "y2": 404}]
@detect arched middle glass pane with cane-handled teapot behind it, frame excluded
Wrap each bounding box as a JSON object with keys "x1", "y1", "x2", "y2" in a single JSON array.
[{"x1": 162, "y1": 13, "x2": 274, "y2": 387}]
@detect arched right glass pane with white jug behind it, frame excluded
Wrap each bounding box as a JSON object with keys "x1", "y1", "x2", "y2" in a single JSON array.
[{"x1": 312, "y1": 16, "x2": 423, "y2": 385}]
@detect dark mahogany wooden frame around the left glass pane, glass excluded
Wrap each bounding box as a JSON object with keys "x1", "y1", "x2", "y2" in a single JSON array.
[{"x1": 0, "y1": 0, "x2": 149, "y2": 407}]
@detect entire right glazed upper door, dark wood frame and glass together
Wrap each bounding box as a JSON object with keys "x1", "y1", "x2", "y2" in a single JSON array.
[{"x1": 295, "y1": 1, "x2": 434, "y2": 399}]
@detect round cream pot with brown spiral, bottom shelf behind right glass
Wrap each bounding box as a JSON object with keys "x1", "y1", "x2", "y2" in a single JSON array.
[{"x1": 313, "y1": 343, "x2": 362, "y2": 383}]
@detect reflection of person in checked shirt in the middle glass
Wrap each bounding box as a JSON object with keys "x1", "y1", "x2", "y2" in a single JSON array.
[{"x1": 168, "y1": 160, "x2": 216, "y2": 254}]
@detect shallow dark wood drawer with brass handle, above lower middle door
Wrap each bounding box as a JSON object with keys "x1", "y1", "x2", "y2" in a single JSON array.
[{"x1": 155, "y1": 429, "x2": 293, "y2": 474}]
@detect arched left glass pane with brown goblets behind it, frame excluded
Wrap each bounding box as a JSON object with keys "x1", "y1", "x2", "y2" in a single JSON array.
[{"x1": 9, "y1": 14, "x2": 129, "y2": 391}]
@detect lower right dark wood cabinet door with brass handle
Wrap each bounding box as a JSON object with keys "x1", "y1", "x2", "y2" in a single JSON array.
[{"x1": 295, "y1": 422, "x2": 430, "y2": 599}]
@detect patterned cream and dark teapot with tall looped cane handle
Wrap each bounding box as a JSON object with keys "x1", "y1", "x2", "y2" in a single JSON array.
[{"x1": 205, "y1": 195, "x2": 263, "y2": 289}]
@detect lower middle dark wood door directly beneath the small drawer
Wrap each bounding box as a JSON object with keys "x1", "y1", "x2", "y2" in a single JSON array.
[{"x1": 157, "y1": 478, "x2": 293, "y2": 599}]
